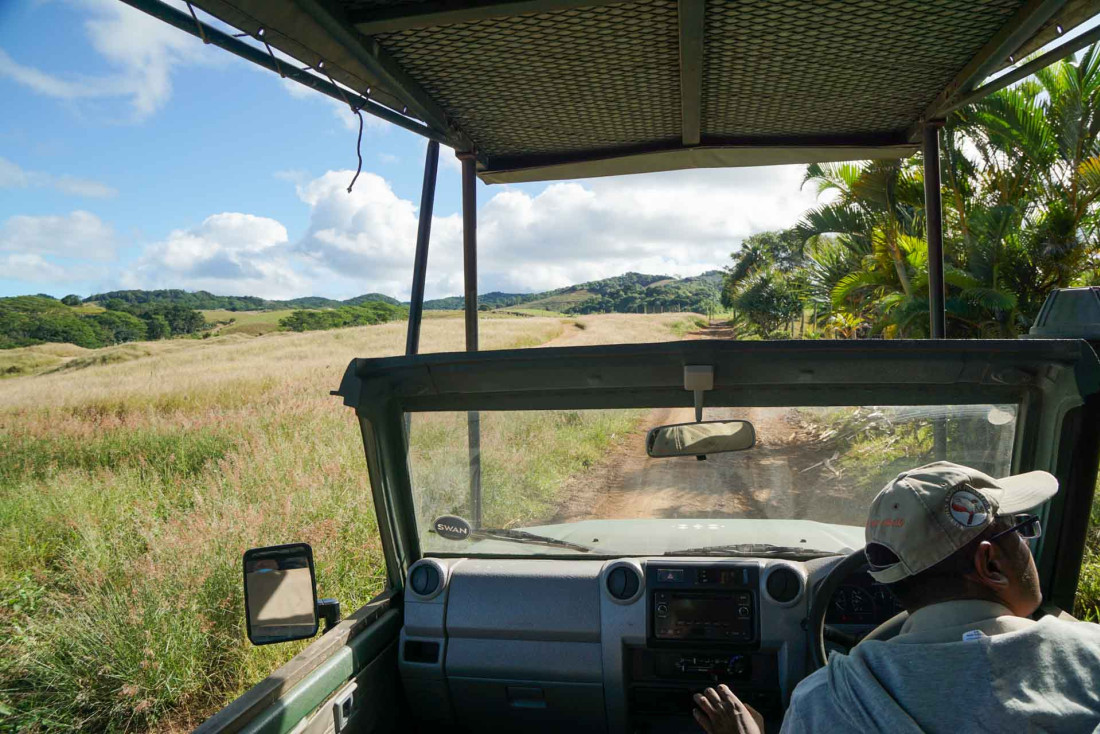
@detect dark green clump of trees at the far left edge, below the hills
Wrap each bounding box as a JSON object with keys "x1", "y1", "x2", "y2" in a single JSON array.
[{"x1": 0, "y1": 295, "x2": 206, "y2": 349}]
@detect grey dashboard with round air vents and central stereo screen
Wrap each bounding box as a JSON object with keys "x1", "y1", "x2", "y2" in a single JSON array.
[{"x1": 398, "y1": 557, "x2": 866, "y2": 734}]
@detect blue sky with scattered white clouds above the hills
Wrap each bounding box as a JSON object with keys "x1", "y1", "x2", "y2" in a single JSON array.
[{"x1": 0, "y1": 0, "x2": 815, "y2": 299}]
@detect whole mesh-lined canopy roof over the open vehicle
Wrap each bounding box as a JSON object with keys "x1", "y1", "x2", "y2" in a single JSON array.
[{"x1": 133, "y1": 0, "x2": 1100, "y2": 183}]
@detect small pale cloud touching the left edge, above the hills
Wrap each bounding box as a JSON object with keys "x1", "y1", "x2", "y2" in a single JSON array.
[{"x1": 0, "y1": 210, "x2": 114, "y2": 260}]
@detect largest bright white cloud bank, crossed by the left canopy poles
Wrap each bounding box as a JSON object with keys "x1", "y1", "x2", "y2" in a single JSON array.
[{"x1": 295, "y1": 166, "x2": 813, "y2": 297}]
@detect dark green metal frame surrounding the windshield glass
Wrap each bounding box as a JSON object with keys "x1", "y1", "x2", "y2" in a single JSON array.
[{"x1": 337, "y1": 340, "x2": 1100, "y2": 599}]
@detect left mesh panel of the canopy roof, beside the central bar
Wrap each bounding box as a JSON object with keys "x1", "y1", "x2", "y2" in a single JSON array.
[{"x1": 376, "y1": 0, "x2": 680, "y2": 155}]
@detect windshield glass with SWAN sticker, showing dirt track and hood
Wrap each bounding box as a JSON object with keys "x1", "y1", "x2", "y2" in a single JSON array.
[{"x1": 409, "y1": 405, "x2": 1016, "y2": 557}]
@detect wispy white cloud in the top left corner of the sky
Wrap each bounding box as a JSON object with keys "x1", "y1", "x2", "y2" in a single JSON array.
[{"x1": 0, "y1": 0, "x2": 227, "y2": 120}]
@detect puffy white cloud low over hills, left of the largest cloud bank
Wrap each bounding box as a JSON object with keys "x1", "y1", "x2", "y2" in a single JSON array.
[{"x1": 122, "y1": 212, "x2": 310, "y2": 298}]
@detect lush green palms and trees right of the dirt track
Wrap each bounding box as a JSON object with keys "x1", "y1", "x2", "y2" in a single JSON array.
[{"x1": 723, "y1": 48, "x2": 1100, "y2": 338}]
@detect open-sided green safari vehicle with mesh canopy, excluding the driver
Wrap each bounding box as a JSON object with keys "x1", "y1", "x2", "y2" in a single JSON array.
[{"x1": 124, "y1": 0, "x2": 1100, "y2": 733}]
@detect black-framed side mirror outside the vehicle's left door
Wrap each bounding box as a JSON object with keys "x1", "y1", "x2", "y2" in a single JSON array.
[{"x1": 244, "y1": 543, "x2": 318, "y2": 645}]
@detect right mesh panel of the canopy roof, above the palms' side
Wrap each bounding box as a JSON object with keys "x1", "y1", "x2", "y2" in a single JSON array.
[{"x1": 703, "y1": 0, "x2": 1021, "y2": 138}]
